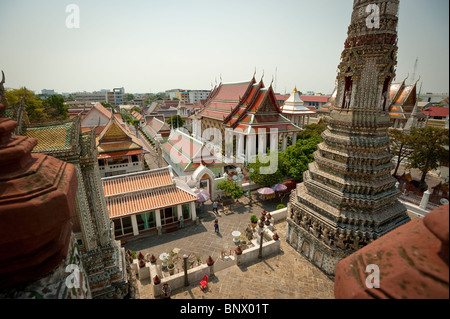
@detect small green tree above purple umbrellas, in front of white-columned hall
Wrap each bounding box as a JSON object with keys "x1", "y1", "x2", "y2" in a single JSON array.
[{"x1": 248, "y1": 151, "x2": 284, "y2": 187}]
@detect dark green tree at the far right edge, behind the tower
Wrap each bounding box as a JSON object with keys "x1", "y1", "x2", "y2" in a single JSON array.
[{"x1": 406, "y1": 126, "x2": 449, "y2": 189}]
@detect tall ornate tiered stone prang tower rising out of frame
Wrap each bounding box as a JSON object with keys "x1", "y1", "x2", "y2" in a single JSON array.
[{"x1": 286, "y1": 0, "x2": 409, "y2": 276}]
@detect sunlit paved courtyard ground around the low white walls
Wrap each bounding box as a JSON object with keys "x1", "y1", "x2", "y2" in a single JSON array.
[{"x1": 124, "y1": 193, "x2": 334, "y2": 299}]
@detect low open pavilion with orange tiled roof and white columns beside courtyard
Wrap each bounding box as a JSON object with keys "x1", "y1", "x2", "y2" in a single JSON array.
[{"x1": 102, "y1": 166, "x2": 197, "y2": 238}]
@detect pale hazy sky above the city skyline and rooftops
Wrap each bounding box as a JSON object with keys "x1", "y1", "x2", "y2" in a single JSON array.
[{"x1": 0, "y1": 0, "x2": 449, "y2": 93}]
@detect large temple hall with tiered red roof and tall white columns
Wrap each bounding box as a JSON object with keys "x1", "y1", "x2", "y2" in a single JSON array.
[{"x1": 192, "y1": 77, "x2": 302, "y2": 161}]
